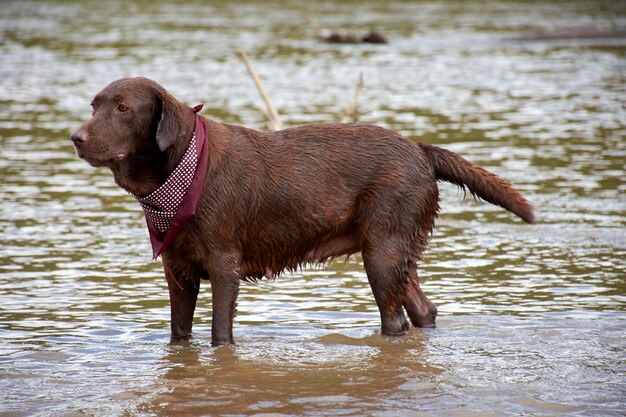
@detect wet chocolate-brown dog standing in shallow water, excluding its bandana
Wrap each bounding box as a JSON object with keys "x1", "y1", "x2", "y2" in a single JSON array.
[{"x1": 72, "y1": 78, "x2": 534, "y2": 345}]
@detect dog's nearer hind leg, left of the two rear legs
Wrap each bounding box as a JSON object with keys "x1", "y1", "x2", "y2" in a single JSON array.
[{"x1": 363, "y1": 245, "x2": 409, "y2": 336}]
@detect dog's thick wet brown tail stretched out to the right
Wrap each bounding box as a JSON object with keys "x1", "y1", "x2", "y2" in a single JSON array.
[{"x1": 419, "y1": 143, "x2": 535, "y2": 223}]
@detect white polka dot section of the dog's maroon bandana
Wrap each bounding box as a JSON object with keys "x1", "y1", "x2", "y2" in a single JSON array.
[{"x1": 133, "y1": 133, "x2": 198, "y2": 233}]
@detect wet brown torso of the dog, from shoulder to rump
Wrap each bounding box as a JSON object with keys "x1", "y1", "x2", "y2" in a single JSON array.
[{"x1": 197, "y1": 124, "x2": 438, "y2": 278}]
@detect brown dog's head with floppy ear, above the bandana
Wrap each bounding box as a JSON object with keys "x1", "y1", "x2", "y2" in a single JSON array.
[{"x1": 72, "y1": 78, "x2": 194, "y2": 172}]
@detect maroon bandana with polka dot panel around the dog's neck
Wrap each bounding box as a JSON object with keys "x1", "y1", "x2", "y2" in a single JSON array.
[{"x1": 133, "y1": 104, "x2": 209, "y2": 259}]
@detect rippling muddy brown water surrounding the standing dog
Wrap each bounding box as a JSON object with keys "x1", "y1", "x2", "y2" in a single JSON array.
[{"x1": 0, "y1": 0, "x2": 626, "y2": 416}]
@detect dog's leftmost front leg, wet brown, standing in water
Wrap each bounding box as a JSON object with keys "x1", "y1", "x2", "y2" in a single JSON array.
[{"x1": 164, "y1": 263, "x2": 200, "y2": 340}]
